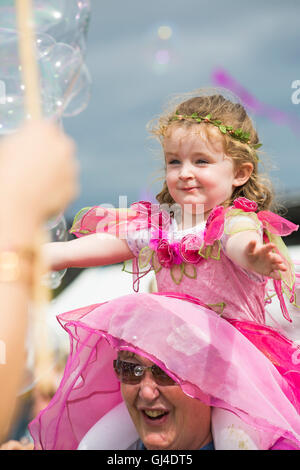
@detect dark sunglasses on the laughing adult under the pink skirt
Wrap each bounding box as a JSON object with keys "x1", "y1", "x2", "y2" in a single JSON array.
[{"x1": 113, "y1": 359, "x2": 176, "y2": 385}]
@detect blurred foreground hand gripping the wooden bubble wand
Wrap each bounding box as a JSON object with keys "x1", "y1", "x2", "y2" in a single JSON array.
[{"x1": 0, "y1": 121, "x2": 78, "y2": 224}]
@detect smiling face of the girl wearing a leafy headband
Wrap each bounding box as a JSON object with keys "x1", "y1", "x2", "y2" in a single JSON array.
[{"x1": 163, "y1": 125, "x2": 240, "y2": 220}]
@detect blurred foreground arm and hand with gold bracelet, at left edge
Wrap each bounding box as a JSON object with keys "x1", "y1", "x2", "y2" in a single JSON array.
[{"x1": 0, "y1": 122, "x2": 77, "y2": 443}]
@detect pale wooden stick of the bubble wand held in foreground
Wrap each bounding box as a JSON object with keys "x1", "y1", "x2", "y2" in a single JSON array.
[{"x1": 15, "y1": 0, "x2": 52, "y2": 393}]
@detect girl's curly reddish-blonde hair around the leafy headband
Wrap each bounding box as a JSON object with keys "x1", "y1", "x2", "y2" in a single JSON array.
[{"x1": 148, "y1": 90, "x2": 274, "y2": 210}]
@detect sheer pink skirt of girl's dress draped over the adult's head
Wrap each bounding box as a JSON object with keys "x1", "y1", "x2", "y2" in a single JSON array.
[{"x1": 30, "y1": 293, "x2": 300, "y2": 450}]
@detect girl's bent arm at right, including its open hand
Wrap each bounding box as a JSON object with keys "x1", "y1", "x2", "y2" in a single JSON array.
[{"x1": 226, "y1": 230, "x2": 287, "y2": 280}]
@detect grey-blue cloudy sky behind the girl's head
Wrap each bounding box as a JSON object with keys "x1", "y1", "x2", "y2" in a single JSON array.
[{"x1": 60, "y1": 0, "x2": 300, "y2": 216}]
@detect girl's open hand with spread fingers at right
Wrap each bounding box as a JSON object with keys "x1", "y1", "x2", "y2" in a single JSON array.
[{"x1": 245, "y1": 240, "x2": 287, "y2": 280}]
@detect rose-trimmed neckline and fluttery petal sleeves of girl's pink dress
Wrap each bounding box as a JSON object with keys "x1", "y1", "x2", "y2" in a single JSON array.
[{"x1": 70, "y1": 197, "x2": 298, "y2": 321}]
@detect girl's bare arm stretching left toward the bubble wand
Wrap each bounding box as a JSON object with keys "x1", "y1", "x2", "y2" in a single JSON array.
[{"x1": 43, "y1": 233, "x2": 134, "y2": 271}]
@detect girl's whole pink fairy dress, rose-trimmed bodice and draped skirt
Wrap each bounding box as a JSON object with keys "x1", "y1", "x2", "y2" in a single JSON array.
[{"x1": 30, "y1": 198, "x2": 300, "y2": 449}]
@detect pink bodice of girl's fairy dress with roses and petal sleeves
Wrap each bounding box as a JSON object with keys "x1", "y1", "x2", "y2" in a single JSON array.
[{"x1": 71, "y1": 198, "x2": 300, "y2": 325}]
